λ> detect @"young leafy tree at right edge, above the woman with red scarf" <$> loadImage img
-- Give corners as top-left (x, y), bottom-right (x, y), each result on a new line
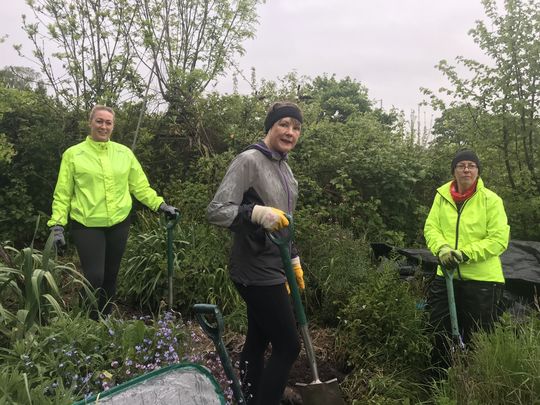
top-left (428, 0), bottom-right (540, 195)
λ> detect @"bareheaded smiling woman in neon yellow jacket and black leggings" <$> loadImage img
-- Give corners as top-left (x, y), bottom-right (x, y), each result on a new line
top-left (47, 105), bottom-right (176, 318)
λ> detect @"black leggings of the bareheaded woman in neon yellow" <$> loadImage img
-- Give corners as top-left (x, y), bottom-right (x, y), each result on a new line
top-left (71, 217), bottom-right (130, 319)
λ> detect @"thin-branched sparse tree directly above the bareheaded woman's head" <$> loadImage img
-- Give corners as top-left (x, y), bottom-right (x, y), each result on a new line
top-left (18, 0), bottom-right (141, 109)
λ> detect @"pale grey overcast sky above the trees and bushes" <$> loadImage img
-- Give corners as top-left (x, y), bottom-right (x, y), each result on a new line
top-left (0, 0), bottom-right (485, 116)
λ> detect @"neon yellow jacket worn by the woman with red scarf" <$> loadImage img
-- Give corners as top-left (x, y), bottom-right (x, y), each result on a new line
top-left (424, 178), bottom-right (510, 283)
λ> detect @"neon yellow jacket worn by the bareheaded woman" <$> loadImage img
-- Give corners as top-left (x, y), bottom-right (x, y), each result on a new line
top-left (47, 136), bottom-right (163, 227)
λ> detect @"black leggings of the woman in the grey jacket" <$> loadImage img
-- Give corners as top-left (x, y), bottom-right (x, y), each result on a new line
top-left (236, 284), bottom-right (300, 405)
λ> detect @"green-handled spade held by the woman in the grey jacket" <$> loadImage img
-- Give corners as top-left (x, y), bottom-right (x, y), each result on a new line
top-left (267, 215), bottom-right (345, 405)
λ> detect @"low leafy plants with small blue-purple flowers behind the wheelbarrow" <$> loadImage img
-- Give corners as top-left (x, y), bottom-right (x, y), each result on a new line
top-left (0, 312), bottom-right (234, 404)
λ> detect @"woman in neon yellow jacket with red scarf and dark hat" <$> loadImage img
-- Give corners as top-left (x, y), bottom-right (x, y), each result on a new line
top-left (424, 150), bottom-right (510, 366)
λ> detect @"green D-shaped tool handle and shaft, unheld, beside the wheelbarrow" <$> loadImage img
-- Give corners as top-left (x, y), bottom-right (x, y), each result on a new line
top-left (193, 304), bottom-right (246, 404)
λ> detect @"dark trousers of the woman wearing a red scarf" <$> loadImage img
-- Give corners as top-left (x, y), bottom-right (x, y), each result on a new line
top-left (428, 276), bottom-right (504, 368)
